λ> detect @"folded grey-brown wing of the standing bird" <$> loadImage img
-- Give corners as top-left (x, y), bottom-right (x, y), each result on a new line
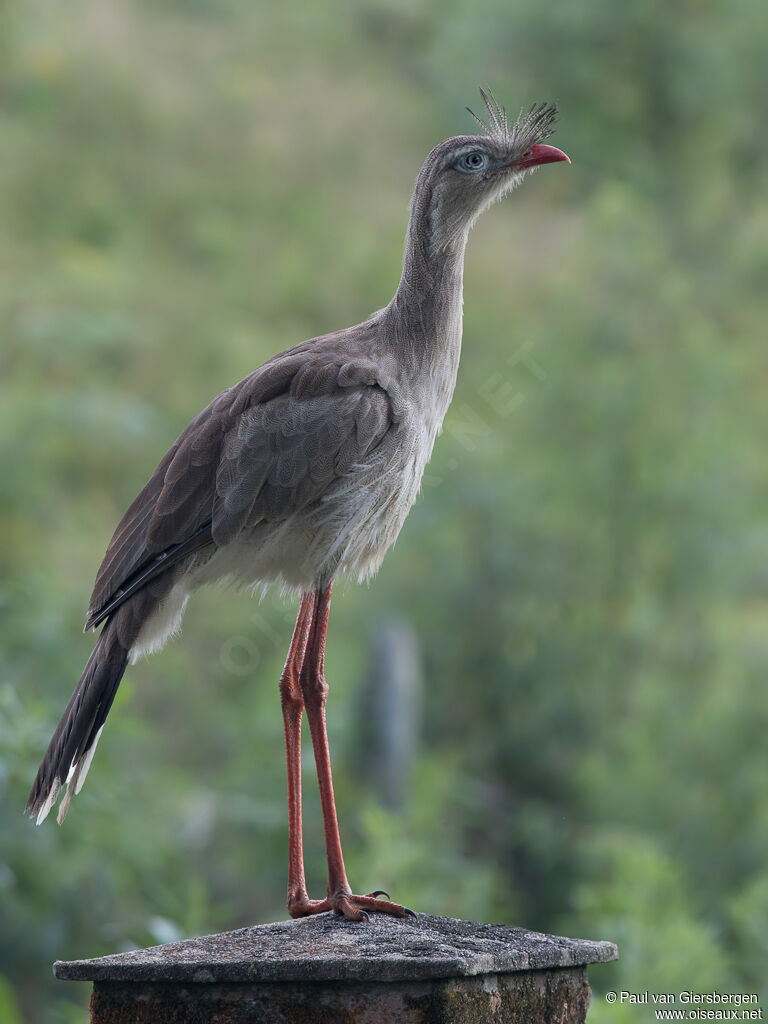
top-left (86, 343), bottom-right (397, 628)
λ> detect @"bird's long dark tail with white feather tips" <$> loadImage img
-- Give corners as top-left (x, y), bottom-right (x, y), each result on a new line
top-left (27, 609), bottom-right (129, 824)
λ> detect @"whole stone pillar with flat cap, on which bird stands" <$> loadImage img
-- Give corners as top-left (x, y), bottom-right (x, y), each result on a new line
top-left (53, 913), bottom-right (617, 1024)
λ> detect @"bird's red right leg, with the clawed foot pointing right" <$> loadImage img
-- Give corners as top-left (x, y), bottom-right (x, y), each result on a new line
top-left (294, 585), bottom-right (416, 921)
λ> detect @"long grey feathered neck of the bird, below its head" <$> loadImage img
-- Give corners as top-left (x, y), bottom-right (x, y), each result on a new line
top-left (385, 191), bottom-right (467, 372)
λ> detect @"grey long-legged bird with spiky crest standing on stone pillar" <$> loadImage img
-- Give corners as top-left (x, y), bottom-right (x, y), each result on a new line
top-left (26, 89), bottom-right (570, 921)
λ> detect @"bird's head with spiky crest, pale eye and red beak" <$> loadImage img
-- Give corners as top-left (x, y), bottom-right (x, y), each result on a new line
top-left (414, 89), bottom-right (570, 250)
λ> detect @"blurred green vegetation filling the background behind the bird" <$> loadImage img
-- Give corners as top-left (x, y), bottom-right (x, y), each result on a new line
top-left (0, 0), bottom-right (768, 1024)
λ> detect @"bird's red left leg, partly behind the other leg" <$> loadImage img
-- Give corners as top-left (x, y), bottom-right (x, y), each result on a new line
top-left (280, 594), bottom-right (328, 918)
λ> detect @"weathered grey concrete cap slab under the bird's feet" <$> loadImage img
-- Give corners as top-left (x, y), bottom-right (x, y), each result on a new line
top-left (53, 913), bottom-right (618, 984)
